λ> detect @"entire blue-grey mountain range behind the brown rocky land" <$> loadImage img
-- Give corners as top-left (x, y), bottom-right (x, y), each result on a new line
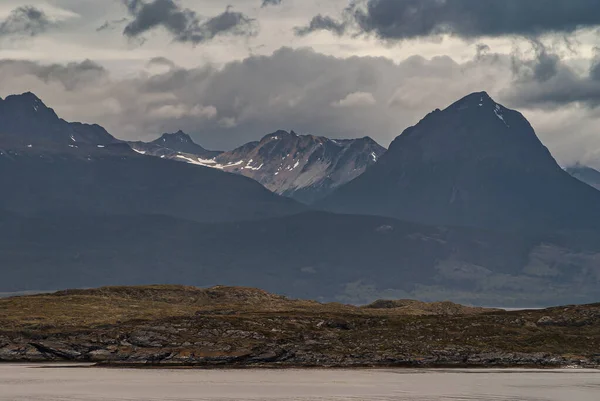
top-left (0, 93), bottom-right (600, 306)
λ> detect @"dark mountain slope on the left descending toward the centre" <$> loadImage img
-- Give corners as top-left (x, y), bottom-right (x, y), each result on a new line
top-left (0, 94), bottom-right (304, 221)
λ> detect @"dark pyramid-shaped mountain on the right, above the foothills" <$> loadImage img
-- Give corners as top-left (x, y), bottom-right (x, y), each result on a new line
top-left (319, 93), bottom-right (600, 231)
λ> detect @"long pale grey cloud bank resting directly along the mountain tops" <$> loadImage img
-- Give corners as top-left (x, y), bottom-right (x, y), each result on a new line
top-left (0, 47), bottom-right (600, 166)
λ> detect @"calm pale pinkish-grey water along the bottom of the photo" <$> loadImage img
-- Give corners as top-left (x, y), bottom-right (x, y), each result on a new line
top-left (0, 365), bottom-right (600, 401)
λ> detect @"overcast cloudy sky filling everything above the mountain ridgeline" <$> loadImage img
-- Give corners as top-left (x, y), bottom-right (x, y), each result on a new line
top-left (0, 0), bottom-right (600, 167)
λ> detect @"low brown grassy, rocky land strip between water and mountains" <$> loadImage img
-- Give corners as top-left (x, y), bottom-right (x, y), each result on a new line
top-left (0, 287), bottom-right (600, 369)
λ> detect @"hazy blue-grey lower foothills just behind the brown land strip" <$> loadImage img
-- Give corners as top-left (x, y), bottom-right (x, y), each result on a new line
top-left (0, 212), bottom-right (600, 306)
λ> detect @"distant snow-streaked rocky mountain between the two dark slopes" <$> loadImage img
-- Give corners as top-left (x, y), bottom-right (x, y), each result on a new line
top-left (130, 131), bottom-right (385, 203)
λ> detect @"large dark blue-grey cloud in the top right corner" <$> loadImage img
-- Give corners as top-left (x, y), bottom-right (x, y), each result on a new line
top-left (304, 0), bottom-right (600, 40)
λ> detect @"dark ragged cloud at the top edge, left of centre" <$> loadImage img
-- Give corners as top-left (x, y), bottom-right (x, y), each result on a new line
top-left (123, 0), bottom-right (257, 44)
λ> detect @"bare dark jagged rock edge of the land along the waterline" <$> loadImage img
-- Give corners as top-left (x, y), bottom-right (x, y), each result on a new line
top-left (0, 341), bottom-right (600, 369)
